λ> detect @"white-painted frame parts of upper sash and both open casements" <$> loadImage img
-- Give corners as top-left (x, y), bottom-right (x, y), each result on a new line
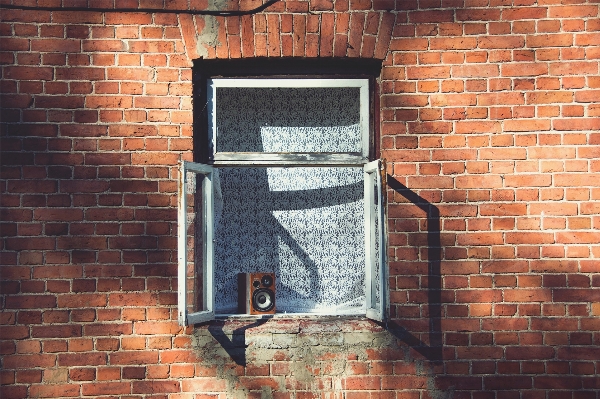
top-left (178, 78), bottom-right (388, 326)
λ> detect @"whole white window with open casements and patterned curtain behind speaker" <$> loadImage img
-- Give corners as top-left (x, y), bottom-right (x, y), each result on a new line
top-left (178, 68), bottom-right (387, 325)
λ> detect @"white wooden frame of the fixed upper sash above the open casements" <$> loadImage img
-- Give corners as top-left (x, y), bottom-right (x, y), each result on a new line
top-left (207, 78), bottom-right (370, 166)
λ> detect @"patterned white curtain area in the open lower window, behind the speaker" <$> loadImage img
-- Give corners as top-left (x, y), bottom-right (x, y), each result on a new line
top-left (214, 167), bottom-right (365, 314)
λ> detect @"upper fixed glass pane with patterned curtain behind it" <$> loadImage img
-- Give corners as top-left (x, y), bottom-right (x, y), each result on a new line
top-left (216, 87), bottom-right (362, 153)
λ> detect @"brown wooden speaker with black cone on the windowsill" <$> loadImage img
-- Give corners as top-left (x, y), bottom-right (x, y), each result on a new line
top-left (238, 273), bottom-right (275, 314)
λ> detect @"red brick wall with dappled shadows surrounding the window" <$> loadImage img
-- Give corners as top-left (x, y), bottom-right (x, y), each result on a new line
top-left (0, 0), bottom-right (600, 399)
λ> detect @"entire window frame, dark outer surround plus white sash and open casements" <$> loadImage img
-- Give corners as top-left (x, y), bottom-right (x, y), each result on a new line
top-left (178, 59), bottom-right (389, 325)
